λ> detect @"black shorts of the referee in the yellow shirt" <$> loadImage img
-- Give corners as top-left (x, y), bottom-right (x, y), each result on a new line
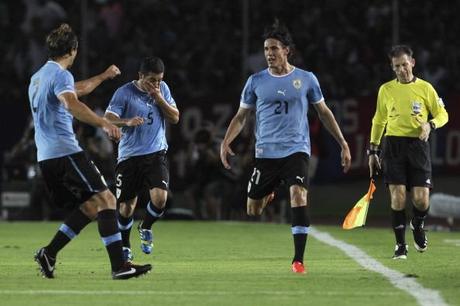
top-left (382, 136), bottom-right (433, 190)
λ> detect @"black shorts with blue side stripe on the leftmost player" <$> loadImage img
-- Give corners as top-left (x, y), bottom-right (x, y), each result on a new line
top-left (38, 152), bottom-right (107, 207)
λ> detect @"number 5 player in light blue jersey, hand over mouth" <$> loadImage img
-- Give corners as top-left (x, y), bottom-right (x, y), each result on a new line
top-left (105, 57), bottom-right (179, 260)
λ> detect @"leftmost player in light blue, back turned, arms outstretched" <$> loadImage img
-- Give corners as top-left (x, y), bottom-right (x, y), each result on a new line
top-left (29, 24), bottom-right (151, 279)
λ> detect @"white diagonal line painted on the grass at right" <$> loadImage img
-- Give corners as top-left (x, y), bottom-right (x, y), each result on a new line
top-left (309, 228), bottom-right (448, 306)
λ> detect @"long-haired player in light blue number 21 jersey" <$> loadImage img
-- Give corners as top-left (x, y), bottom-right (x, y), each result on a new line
top-left (220, 21), bottom-right (351, 273)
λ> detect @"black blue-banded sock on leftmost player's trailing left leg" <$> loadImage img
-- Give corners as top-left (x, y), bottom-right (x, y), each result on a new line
top-left (45, 208), bottom-right (91, 258)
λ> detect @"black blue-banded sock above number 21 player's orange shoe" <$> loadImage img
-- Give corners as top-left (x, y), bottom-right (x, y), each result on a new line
top-left (291, 206), bottom-right (310, 263)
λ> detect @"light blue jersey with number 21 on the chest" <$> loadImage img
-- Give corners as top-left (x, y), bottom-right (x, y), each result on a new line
top-left (240, 68), bottom-right (324, 158)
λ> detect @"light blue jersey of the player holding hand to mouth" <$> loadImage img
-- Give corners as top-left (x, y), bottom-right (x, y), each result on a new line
top-left (106, 81), bottom-right (176, 162)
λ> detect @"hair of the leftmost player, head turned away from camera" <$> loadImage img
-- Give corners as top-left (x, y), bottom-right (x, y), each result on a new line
top-left (46, 23), bottom-right (78, 59)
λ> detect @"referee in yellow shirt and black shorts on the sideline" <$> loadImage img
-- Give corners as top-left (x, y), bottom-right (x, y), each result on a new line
top-left (368, 45), bottom-right (448, 259)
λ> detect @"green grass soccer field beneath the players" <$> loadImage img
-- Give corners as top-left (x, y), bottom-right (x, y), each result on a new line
top-left (0, 221), bottom-right (460, 306)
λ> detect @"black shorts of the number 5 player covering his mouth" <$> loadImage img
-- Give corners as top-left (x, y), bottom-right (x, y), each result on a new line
top-left (115, 150), bottom-right (169, 202)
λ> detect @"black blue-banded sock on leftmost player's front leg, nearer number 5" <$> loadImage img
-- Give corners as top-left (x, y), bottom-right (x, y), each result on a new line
top-left (97, 209), bottom-right (124, 271)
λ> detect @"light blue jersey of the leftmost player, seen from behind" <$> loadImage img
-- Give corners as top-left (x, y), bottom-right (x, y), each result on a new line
top-left (29, 61), bottom-right (82, 161)
